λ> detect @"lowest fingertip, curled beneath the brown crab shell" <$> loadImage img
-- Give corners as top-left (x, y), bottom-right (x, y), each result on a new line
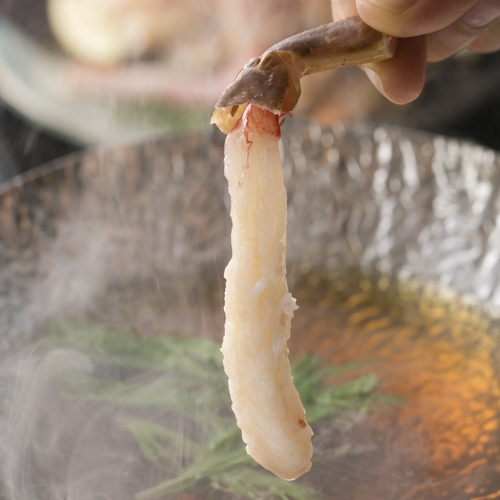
top-left (363, 36), bottom-right (427, 104)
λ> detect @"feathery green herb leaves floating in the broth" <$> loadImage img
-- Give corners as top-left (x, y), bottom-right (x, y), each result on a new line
top-left (50, 325), bottom-right (387, 500)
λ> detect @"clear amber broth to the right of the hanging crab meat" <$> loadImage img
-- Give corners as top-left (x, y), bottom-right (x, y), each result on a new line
top-left (290, 271), bottom-right (500, 499)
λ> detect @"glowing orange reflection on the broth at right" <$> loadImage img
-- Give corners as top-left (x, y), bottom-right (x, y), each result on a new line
top-left (290, 274), bottom-right (500, 482)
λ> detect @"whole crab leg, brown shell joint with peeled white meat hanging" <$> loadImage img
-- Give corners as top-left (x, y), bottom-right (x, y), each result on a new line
top-left (212, 17), bottom-right (394, 480)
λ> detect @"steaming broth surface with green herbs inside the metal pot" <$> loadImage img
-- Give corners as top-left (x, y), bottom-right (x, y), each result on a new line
top-left (2, 270), bottom-right (500, 500)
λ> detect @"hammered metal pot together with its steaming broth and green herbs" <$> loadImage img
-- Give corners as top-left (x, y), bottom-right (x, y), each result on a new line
top-left (1, 124), bottom-right (500, 499)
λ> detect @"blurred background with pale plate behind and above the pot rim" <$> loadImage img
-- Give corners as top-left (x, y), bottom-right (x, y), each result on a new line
top-left (0, 0), bottom-right (500, 182)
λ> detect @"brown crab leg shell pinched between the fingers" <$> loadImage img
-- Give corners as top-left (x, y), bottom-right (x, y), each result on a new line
top-left (210, 17), bottom-right (395, 134)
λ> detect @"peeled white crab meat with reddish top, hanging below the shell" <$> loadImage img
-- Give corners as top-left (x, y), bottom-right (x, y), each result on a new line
top-left (222, 105), bottom-right (313, 480)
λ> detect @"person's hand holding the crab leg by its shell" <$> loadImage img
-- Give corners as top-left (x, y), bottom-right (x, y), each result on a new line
top-left (331, 0), bottom-right (500, 104)
